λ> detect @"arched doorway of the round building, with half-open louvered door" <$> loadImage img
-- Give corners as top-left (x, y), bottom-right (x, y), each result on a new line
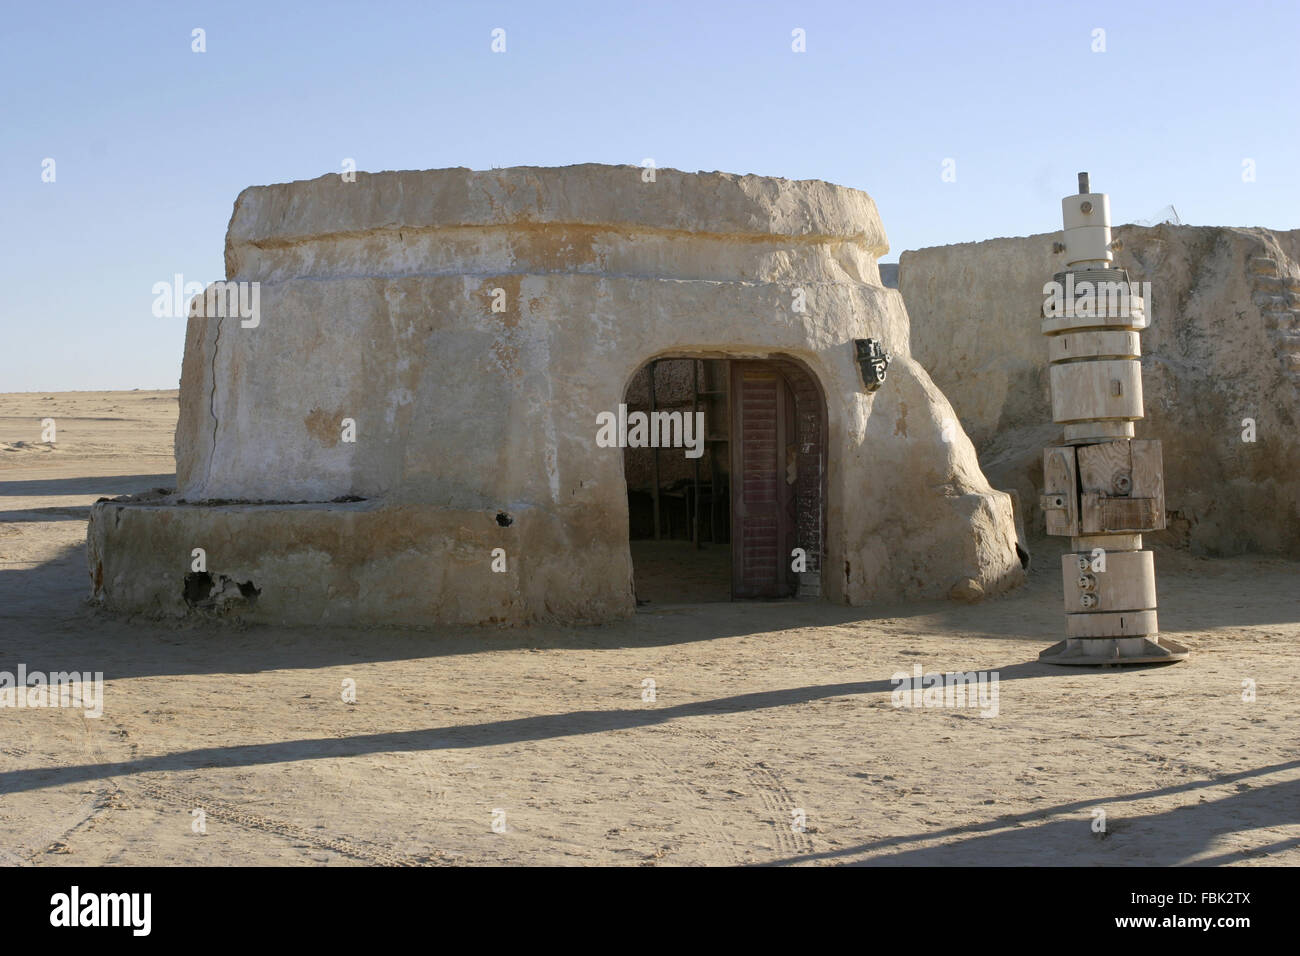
top-left (624, 354), bottom-right (827, 606)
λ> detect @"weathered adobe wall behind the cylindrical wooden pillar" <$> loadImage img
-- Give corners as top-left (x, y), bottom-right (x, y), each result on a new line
top-left (898, 224), bottom-right (1300, 555)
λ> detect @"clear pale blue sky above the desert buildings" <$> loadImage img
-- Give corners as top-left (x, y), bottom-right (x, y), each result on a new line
top-left (0, 0), bottom-right (1300, 392)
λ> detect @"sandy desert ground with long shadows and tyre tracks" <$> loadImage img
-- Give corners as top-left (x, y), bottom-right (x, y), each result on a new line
top-left (0, 392), bottom-right (1300, 865)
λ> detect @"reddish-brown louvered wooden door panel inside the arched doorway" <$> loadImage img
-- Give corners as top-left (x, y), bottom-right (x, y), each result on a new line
top-left (731, 362), bottom-right (794, 598)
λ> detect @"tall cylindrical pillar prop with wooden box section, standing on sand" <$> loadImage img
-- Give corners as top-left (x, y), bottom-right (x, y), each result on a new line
top-left (1039, 173), bottom-right (1187, 666)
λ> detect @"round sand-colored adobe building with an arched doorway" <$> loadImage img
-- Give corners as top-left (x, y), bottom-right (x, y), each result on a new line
top-left (88, 165), bottom-right (1023, 624)
